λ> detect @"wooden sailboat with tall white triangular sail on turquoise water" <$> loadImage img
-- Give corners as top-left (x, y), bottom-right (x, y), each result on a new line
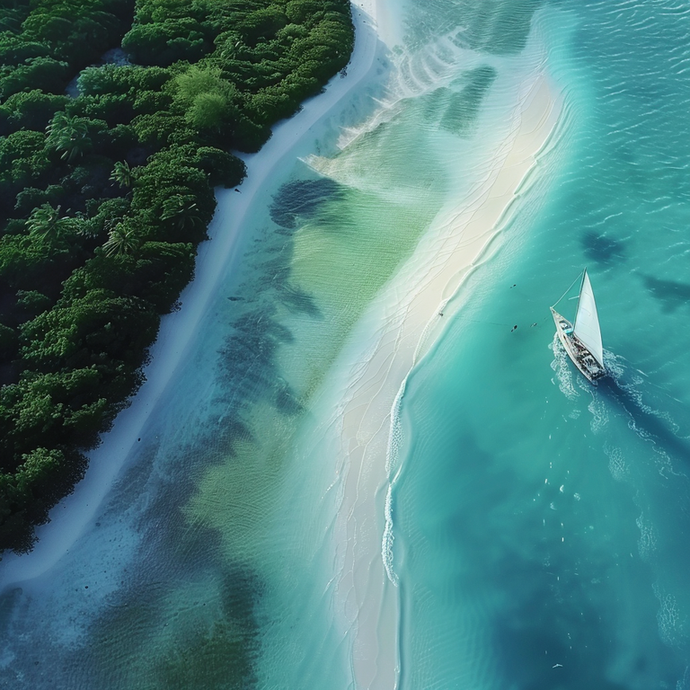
top-left (551, 269), bottom-right (607, 382)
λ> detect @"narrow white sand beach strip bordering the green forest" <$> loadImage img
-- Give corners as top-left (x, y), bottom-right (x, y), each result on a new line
top-left (0, 0), bottom-right (378, 591)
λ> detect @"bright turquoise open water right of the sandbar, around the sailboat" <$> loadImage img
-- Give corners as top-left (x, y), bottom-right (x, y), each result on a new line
top-left (394, 3), bottom-right (690, 690)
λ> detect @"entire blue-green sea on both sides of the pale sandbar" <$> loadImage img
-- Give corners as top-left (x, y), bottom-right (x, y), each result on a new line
top-left (0, 0), bottom-right (690, 690)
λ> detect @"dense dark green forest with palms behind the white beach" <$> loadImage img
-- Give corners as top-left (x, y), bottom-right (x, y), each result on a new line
top-left (0, 0), bottom-right (354, 551)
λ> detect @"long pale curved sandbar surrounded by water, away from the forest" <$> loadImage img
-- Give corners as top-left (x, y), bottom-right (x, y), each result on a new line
top-left (330, 68), bottom-right (561, 690)
